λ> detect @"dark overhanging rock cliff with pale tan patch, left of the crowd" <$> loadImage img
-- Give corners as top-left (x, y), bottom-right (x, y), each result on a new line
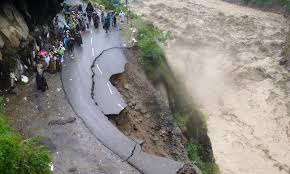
top-left (0, 0), bottom-right (63, 89)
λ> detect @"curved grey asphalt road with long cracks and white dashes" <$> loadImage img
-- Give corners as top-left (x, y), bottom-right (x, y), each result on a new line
top-left (60, 1), bottom-right (183, 174)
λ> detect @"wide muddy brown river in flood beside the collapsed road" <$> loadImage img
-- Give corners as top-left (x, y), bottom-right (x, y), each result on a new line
top-left (131, 0), bottom-right (290, 174)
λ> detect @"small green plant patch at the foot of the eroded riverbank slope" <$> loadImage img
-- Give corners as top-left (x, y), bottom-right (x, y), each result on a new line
top-left (186, 140), bottom-right (220, 174)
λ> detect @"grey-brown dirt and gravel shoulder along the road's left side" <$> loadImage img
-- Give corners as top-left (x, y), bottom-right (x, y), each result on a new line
top-left (5, 74), bottom-right (139, 174)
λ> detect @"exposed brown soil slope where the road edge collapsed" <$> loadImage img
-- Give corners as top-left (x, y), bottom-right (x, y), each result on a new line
top-left (111, 50), bottom-right (188, 161)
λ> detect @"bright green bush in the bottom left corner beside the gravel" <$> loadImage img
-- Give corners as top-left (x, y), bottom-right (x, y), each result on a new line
top-left (0, 97), bottom-right (51, 174)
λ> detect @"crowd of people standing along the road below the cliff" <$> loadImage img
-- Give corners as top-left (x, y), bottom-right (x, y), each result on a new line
top-left (17, 3), bottom-right (125, 92)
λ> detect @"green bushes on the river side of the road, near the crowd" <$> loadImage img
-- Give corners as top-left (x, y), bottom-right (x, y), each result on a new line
top-left (123, 14), bottom-right (173, 81)
